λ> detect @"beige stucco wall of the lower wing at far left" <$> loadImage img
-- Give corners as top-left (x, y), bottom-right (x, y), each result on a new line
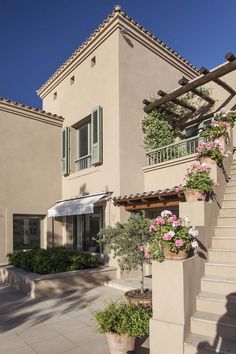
top-left (0, 106), bottom-right (61, 262)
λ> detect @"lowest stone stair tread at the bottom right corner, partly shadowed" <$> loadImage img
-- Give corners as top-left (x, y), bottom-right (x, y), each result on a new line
top-left (186, 333), bottom-right (236, 354)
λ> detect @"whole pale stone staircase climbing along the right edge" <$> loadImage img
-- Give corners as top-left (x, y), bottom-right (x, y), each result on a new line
top-left (184, 160), bottom-right (236, 354)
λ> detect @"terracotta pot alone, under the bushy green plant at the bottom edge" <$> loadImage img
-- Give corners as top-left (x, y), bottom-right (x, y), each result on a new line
top-left (106, 333), bottom-right (135, 354)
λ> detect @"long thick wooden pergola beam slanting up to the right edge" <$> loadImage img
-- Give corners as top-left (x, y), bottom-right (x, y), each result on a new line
top-left (144, 53), bottom-right (236, 113)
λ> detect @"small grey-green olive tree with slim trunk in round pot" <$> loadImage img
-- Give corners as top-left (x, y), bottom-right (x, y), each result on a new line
top-left (97, 213), bottom-right (152, 306)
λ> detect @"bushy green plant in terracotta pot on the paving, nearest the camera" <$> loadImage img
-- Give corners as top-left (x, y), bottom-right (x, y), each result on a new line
top-left (94, 301), bottom-right (152, 354)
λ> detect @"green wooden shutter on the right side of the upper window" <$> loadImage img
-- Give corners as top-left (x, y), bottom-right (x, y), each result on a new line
top-left (91, 106), bottom-right (103, 165)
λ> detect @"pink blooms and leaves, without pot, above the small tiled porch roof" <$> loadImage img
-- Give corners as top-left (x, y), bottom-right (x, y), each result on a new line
top-left (182, 161), bottom-right (215, 199)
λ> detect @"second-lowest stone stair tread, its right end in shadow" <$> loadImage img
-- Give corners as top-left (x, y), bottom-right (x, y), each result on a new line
top-left (192, 311), bottom-right (236, 328)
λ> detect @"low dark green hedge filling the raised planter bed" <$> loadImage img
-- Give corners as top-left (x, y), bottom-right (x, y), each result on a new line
top-left (9, 247), bottom-right (99, 274)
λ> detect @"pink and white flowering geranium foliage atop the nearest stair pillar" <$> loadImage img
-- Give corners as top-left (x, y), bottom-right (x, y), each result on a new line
top-left (140, 210), bottom-right (198, 262)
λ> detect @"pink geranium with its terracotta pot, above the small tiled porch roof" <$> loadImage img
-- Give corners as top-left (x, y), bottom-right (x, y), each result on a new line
top-left (181, 161), bottom-right (217, 201)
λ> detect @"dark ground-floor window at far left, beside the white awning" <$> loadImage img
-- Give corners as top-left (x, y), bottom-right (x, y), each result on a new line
top-left (13, 215), bottom-right (42, 250)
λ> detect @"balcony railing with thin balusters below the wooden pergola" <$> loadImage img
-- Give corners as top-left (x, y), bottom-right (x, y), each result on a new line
top-left (147, 136), bottom-right (203, 166)
